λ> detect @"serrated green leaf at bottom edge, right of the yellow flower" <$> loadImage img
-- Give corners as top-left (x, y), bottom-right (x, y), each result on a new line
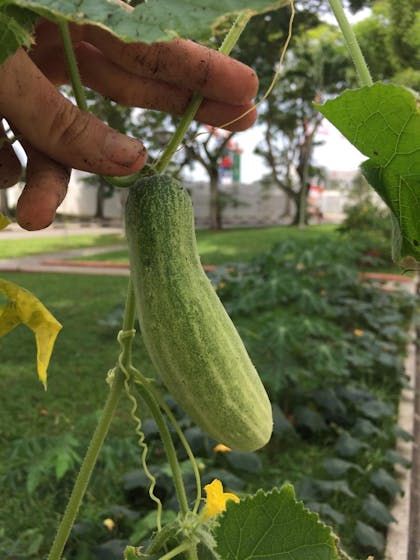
top-left (215, 484), bottom-right (340, 560)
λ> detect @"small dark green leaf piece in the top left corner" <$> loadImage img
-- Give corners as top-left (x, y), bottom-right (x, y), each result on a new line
top-left (0, 3), bottom-right (38, 63)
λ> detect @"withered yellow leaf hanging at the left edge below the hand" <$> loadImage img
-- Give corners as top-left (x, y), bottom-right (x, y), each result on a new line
top-left (0, 279), bottom-right (62, 388)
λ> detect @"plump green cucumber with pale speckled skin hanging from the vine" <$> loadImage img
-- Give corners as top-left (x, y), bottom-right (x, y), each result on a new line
top-left (126, 175), bottom-right (273, 451)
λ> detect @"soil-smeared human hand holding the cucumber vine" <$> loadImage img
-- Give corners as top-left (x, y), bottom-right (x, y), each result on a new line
top-left (0, 20), bottom-right (258, 230)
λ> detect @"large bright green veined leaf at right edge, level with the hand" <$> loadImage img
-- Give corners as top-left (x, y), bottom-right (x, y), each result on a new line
top-left (318, 83), bottom-right (420, 260)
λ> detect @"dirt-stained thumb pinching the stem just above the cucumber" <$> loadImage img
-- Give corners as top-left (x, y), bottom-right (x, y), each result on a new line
top-left (0, 49), bottom-right (147, 175)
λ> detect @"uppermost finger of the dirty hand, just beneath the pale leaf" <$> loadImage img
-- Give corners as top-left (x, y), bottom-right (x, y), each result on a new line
top-left (84, 25), bottom-right (258, 105)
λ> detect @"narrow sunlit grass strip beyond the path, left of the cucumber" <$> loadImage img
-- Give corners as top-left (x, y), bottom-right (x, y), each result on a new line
top-left (0, 232), bottom-right (124, 259)
